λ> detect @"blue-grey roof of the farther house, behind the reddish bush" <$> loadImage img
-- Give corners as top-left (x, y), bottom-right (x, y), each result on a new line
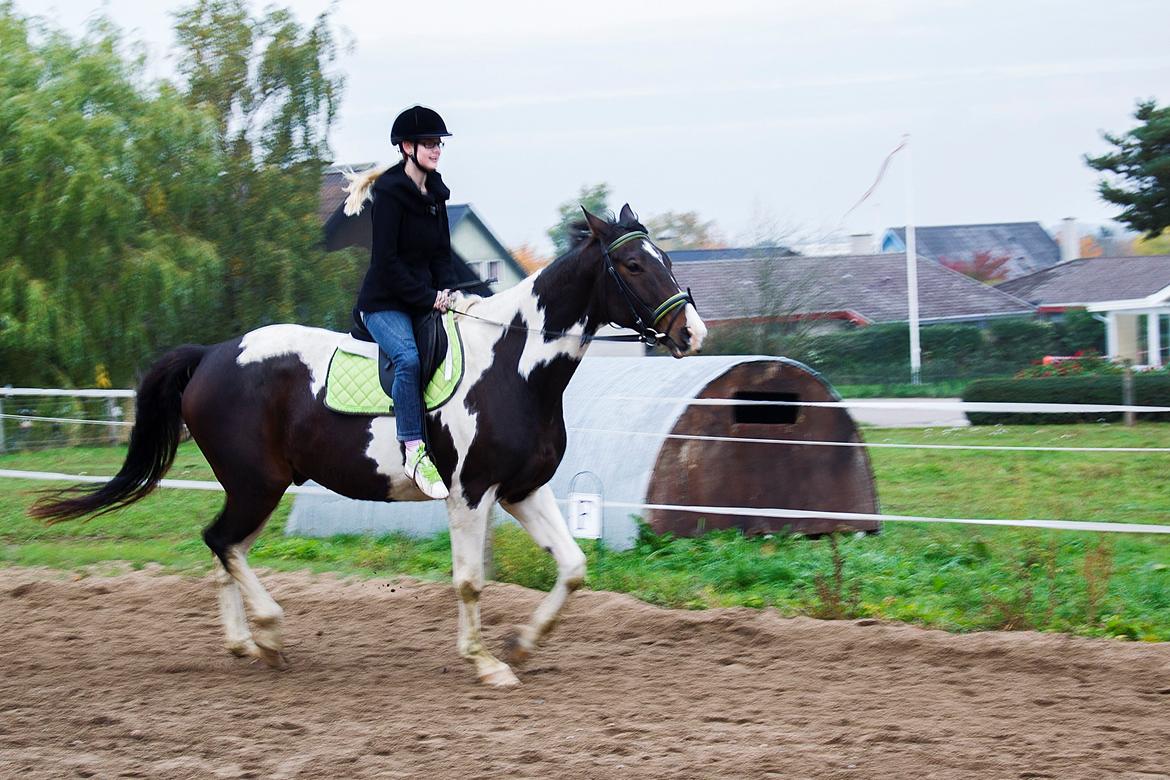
top-left (882, 222), bottom-right (1060, 278)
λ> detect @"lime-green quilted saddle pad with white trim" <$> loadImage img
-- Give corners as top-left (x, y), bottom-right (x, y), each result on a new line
top-left (325, 311), bottom-right (463, 414)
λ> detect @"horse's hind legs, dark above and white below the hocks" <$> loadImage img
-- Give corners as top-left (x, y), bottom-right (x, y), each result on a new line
top-left (204, 488), bottom-right (284, 668)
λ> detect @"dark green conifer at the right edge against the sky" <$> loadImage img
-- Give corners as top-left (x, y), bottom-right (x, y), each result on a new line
top-left (1085, 101), bottom-right (1170, 237)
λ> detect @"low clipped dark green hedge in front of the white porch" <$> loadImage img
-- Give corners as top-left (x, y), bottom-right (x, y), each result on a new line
top-left (963, 372), bottom-right (1170, 426)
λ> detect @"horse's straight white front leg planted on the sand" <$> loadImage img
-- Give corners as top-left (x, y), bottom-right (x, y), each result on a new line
top-left (447, 498), bottom-right (519, 688)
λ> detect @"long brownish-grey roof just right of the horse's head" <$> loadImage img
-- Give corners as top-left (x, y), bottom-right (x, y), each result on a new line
top-left (670, 253), bottom-right (1034, 323)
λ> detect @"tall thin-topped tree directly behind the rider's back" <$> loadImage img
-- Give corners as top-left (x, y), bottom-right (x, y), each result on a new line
top-left (176, 0), bottom-right (346, 336)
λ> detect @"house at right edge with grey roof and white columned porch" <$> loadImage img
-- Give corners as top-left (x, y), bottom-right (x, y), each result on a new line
top-left (996, 255), bottom-right (1170, 366)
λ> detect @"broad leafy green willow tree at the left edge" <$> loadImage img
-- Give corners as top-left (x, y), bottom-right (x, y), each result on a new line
top-left (0, 4), bottom-right (221, 385)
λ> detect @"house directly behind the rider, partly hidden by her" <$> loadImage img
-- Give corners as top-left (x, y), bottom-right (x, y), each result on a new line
top-left (317, 164), bottom-right (527, 295)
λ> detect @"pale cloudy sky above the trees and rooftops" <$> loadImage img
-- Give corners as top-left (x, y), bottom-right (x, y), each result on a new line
top-left (15, 0), bottom-right (1170, 251)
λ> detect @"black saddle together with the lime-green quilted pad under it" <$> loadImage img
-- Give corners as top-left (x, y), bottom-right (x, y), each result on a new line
top-left (325, 311), bottom-right (463, 415)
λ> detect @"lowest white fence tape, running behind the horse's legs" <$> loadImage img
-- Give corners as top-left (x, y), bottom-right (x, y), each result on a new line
top-left (0, 469), bottom-right (1170, 534)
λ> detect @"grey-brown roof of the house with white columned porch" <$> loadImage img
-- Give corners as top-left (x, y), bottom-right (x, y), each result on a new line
top-left (996, 255), bottom-right (1170, 306)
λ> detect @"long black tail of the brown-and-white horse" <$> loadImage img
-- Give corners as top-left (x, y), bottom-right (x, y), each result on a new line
top-left (28, 345), bottom-right (207, 523)
